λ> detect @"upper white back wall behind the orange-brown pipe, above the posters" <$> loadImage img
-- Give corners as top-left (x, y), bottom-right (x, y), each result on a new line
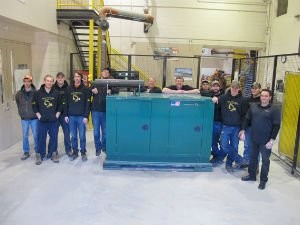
top-left (105, 0), bottom-right (267, 53)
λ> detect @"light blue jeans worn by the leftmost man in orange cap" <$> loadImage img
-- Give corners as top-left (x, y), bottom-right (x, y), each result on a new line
top-left (21, 119), bottom-right (38, 152)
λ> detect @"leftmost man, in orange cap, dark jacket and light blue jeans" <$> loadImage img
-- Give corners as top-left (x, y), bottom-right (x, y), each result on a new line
top-left (16, 74), bottom-right (38, 160)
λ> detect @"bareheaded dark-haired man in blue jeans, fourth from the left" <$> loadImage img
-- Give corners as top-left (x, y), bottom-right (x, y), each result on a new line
top-left (64, 72), bottom-right (91, 162)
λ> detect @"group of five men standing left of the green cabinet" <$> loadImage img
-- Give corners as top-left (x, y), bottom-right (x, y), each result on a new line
top-left (16, 68), bottom-right (115, 165)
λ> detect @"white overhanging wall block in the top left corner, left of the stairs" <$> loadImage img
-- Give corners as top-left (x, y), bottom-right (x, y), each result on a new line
top-left (0, 0), bottom-right (57, 33)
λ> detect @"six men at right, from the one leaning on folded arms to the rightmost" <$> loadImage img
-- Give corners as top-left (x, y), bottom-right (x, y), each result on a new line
top-left (162, 77), bottom-right (281, 189)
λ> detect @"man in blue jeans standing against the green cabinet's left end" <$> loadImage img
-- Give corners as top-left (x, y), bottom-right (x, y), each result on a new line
top-left (91, 68), bottom-right (118, 156)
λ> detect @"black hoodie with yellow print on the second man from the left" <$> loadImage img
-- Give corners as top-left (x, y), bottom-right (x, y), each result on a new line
top-left (32, 84), bottom-right (62, 122)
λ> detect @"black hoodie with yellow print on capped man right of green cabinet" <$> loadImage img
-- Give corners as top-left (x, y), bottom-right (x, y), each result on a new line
top-left (218, 90), bottom-right (249, 126)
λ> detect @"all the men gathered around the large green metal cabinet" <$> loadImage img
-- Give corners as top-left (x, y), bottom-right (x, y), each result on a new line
top-left (16, 72), bottom-right (280, 189)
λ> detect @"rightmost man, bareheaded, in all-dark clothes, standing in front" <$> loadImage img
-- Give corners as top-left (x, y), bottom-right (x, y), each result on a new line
top-left (240, 89), bottom-right (280, 190)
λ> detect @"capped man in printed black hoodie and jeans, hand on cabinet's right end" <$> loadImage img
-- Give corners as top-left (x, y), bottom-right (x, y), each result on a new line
top-left (213, 80), bottom-right (248, 172)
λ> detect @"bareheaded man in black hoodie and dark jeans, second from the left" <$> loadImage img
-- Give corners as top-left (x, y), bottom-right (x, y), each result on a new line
top-left (32, 75), bottom-right (62, 165)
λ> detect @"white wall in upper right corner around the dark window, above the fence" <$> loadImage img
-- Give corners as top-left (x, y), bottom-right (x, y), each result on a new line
top-left (266, 0), bottom-right (300, 55)
